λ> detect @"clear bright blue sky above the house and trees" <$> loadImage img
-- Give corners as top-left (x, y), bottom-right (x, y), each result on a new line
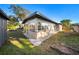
top-left (0, 4), bottom-right (79, 23)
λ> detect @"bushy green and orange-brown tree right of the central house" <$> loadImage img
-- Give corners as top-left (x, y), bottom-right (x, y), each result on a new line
top-left (60, 19), bottom-right (71, 31)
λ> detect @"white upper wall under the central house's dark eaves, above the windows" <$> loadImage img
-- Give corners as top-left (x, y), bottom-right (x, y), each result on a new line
top-left (25, 18), bottom-right (57, 33)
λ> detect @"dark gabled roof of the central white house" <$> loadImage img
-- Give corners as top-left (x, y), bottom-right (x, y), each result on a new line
top-left (22, 11), bottom-right (58, 24)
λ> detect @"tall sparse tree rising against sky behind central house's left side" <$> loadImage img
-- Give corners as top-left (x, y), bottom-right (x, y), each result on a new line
top-left (10, 5), bottom-right (30, 20)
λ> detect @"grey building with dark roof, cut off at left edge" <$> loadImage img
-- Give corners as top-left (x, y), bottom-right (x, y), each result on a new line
top-left (0, 9), bottom-right (9, 47)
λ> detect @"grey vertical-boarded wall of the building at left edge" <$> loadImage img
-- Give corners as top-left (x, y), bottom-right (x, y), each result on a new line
top-left (0, 18), bottom-right (7, 46)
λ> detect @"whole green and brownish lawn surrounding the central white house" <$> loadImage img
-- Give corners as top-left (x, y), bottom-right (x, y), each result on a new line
top-left (0, 30), bottom-right (79, 55)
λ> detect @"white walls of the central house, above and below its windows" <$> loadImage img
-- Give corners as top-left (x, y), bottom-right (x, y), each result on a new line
top-left (24, 18), bottom-right (59, 39)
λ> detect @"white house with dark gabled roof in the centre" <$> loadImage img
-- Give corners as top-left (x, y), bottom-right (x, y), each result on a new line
top-left (22, 11), bottom-right (62, 46)
